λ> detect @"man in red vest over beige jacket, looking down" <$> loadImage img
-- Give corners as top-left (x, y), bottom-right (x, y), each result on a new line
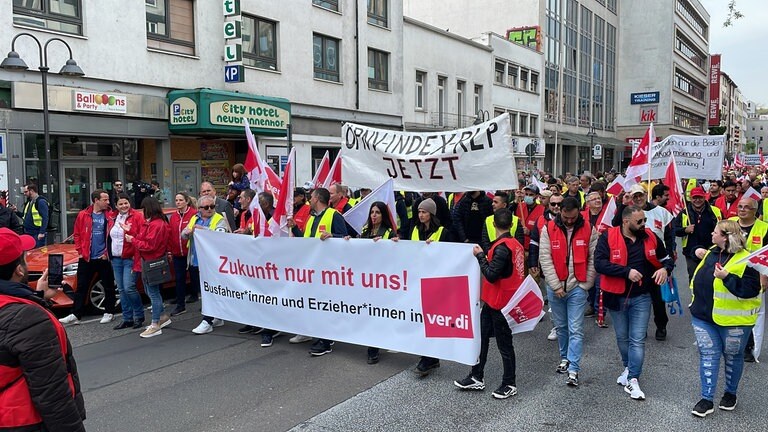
top-left (539, 197), bottom-right (597, 387)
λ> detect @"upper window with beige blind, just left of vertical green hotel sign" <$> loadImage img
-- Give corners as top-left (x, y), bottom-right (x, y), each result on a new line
top-left (145, 0), bottom-right (195, 55)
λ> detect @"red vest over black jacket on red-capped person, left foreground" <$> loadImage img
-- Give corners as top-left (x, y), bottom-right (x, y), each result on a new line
top-left (0, 295), bottom-right (75, 430)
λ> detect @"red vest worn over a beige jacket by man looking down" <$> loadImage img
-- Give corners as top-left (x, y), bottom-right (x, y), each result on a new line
top-left (547, 220), bottom-right (592, 282)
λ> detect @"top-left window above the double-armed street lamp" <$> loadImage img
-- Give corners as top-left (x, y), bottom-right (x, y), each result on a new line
top-left (13, 0), bottom-right (83, 35)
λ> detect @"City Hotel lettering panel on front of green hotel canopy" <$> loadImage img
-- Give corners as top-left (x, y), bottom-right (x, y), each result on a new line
top-left (210, 100), bottom-right (291, 129)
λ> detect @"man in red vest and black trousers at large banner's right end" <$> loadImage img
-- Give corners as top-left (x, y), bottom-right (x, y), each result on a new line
top-left (453, 208), bottom-right (525, 399)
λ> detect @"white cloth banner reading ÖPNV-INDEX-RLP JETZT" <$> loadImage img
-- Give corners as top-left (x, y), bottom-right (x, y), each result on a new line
top-left (341, 114), bottom-right (518, 192)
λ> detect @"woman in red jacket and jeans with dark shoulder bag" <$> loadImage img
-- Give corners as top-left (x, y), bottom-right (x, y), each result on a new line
top-left (125, 197), bottom-right (171, 338)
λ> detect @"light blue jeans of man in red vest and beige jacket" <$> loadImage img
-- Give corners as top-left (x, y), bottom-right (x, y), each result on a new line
top-left (547, 286), bottom-right (587, 372)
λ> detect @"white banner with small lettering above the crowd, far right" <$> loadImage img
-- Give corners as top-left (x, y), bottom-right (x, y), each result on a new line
top-left (642, 135), bottom-right (725, 180)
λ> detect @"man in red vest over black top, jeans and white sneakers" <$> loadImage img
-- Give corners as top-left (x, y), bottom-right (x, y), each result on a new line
top-left (595, 205), bottom-right (675, 400)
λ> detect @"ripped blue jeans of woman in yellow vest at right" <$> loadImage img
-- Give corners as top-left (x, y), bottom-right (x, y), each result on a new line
top-left (691, 317), bottom-right (752, 401)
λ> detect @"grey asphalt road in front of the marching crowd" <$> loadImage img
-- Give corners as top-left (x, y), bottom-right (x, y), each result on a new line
top-left (68, 253), bottom-right (768, 432)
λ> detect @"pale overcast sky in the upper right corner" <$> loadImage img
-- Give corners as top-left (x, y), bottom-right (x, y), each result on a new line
top-left (700, 0), bottom-right (768, 107)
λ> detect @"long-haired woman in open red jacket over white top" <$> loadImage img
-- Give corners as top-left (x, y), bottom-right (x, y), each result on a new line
top-left (107, 192), bottom-right (144, 330)
